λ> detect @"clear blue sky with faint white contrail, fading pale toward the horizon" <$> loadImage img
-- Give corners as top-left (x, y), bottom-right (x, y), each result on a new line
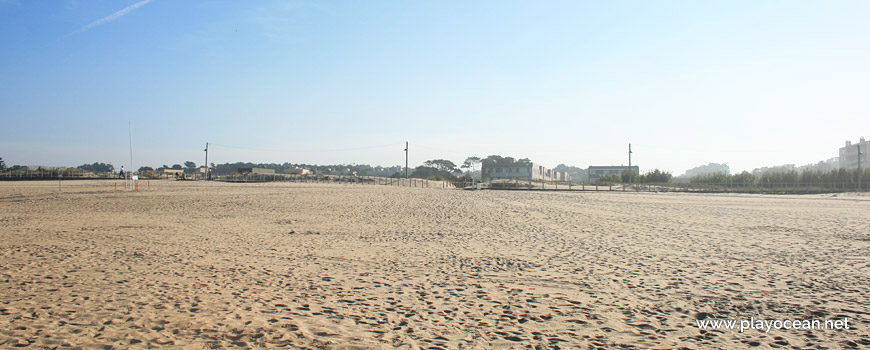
top-left (0, 0), bottom-right (870, 174)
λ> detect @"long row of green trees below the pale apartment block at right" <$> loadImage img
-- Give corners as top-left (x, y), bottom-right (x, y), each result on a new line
top-left (690, 168), bottom-right (870, 185)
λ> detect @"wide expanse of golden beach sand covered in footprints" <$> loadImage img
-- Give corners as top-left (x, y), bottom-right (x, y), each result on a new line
top-left (0, 180), bottom-right (870, 349)
